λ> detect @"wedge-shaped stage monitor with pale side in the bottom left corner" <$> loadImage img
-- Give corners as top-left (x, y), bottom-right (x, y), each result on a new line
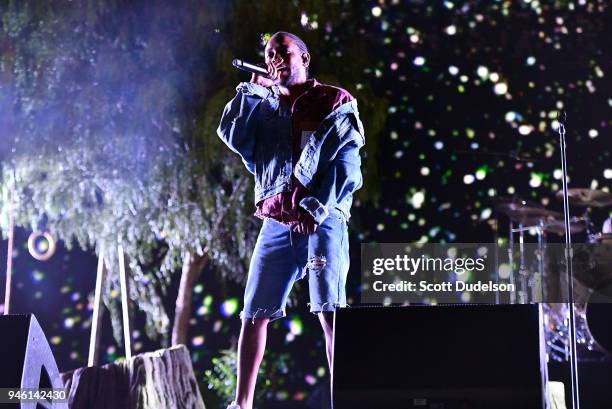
top-left (0, 314), bottom-right (68, 409)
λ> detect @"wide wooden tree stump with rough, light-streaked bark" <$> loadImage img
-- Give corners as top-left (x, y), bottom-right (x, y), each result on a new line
top-left (62, 345), bottom-right (205, 409)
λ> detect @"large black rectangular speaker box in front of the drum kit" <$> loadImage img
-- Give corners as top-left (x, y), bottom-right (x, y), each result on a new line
top-left (332, 305), bottom-right (547, 409)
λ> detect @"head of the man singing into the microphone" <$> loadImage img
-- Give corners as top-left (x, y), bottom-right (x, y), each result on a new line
top-left (265, 35), bottom-right (310, 86)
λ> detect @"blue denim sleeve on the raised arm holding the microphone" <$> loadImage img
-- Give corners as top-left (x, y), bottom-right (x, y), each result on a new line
top-left (217, 82), bottom-right (271, 173)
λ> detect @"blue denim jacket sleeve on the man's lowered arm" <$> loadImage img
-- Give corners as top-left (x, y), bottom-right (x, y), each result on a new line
top-left (295, 114), bottom-right (364, 224)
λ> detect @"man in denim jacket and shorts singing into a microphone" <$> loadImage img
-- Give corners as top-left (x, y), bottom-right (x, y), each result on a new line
top-left (217, 32), bottom-right (365, 409)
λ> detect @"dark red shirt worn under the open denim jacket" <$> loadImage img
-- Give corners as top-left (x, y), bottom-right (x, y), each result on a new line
top-left (255, 79), bottom-right (353, 224)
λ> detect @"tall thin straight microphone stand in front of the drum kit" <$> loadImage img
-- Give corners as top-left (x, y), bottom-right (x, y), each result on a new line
top-left (557, 112), bottom-right (580, 409)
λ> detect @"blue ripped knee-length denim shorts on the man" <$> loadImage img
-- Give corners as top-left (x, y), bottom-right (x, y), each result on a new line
top-left (240, 210), bottom-right (349, 321)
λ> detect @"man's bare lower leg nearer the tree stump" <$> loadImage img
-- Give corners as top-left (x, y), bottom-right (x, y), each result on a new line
top-left (236, 318), bottom-right (270, 409)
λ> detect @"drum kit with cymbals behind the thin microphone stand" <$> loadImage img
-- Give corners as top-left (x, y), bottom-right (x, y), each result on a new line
top-left (495, 188), bottom-right (612, 361)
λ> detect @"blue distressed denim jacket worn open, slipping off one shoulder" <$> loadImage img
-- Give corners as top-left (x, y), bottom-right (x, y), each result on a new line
top-left (217, 82), bottom-right (365, 224)
